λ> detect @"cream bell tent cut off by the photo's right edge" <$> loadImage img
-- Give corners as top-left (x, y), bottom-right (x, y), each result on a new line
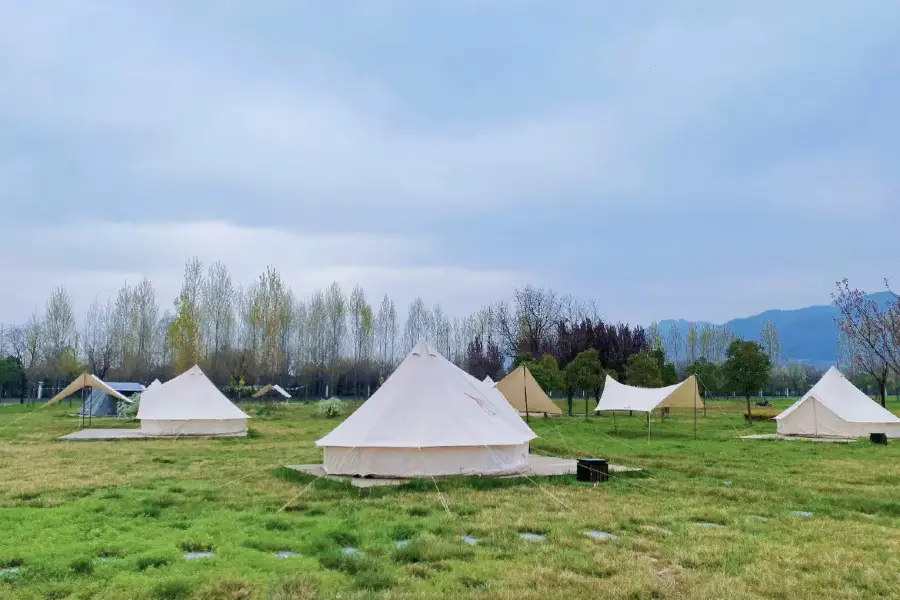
top-left (775, 367), bottom-right (900, 438)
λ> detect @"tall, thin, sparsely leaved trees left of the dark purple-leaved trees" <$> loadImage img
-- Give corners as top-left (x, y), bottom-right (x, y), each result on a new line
top-left (0, 258), bottom-right (646, 395)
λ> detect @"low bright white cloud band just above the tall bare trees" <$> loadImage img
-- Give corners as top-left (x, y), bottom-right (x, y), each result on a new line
top-left (0, 221), bottom-right (529, 323)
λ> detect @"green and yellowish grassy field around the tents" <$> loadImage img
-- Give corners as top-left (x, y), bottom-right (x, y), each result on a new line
top-left (0, 402), bottom-right (900, 600)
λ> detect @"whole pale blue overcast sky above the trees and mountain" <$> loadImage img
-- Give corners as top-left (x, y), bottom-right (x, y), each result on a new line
top-left (0, 0), bottom-right (900, 323)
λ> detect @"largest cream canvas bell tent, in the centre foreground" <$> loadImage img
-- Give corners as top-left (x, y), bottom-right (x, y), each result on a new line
top-left (316, 342), bottom-right (535, 477)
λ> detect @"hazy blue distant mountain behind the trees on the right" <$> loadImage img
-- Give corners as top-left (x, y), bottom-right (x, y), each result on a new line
top-left (659, 291), bottom-right (897, 367)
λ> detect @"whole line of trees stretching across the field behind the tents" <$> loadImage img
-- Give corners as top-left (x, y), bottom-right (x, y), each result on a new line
top-left (0, 258), bottom-right (900, 411)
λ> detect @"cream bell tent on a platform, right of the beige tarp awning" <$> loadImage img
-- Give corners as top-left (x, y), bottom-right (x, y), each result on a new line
top-left (137, 366), bottom-right (250, 436)
